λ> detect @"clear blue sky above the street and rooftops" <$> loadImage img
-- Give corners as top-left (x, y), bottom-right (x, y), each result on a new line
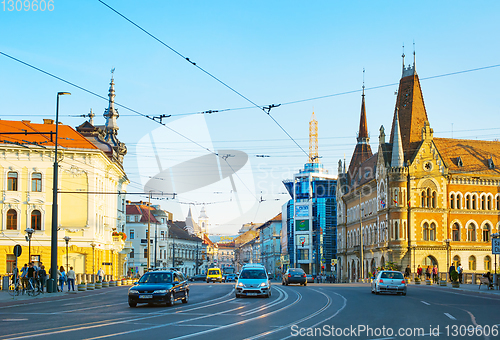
top-left (0, 0), bottom-right (500, 234)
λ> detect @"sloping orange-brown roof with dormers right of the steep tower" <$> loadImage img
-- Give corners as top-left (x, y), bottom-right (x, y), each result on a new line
top-left (433, 138), bottom-right (500, 176)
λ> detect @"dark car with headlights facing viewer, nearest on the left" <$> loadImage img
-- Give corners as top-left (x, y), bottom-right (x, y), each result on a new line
top-left (128, 270), bottom-right (189, 307)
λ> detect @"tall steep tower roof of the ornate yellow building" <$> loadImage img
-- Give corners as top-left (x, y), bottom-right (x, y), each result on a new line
top-left (389, 72), bottom-right (428, 161)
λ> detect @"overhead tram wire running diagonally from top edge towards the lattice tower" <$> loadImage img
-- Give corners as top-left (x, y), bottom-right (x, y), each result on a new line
top-left (98, 0), bottom-right (309, 161)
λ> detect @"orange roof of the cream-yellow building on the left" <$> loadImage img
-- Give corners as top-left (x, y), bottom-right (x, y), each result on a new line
top-left (0, 119), bottom-right (98, 150)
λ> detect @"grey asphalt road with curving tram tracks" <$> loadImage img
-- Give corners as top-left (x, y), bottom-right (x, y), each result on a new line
top-left (0, 283), bottom-right (500, 340)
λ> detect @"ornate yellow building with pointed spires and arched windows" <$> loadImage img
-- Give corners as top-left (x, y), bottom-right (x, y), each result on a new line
top-left (337, 59), bottom-right (500, 281)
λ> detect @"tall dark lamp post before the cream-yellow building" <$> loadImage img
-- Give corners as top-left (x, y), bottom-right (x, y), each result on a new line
top-left (47, 92), bottom-right (71, 293)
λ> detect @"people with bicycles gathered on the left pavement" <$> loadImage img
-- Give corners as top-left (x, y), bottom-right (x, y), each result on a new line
top-left (12, 262), bottom-right (76, 293)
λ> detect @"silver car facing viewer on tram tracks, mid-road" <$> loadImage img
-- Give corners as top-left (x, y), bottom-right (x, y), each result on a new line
top-left (234, 267), bottom-right (271, 298)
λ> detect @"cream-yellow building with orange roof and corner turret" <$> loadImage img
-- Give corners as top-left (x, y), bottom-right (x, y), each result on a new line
top-left (0, 80), bottom-right (129, 281)
